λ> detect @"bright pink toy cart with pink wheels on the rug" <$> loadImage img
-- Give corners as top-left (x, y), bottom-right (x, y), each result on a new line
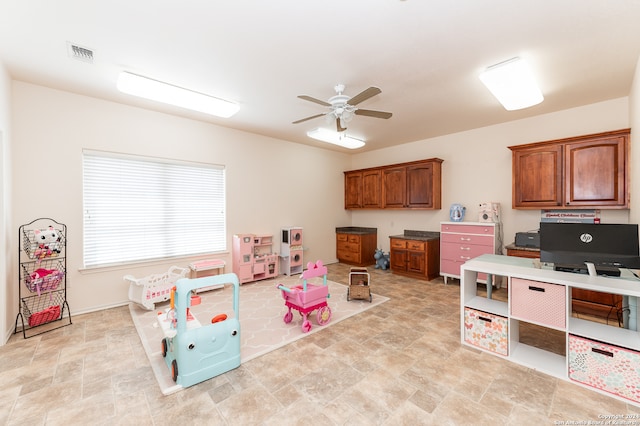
top-left (278, 260), bottom-right (331, 333)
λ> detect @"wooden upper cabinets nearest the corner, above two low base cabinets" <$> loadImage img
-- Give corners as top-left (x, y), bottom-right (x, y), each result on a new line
top-left (344, 158), bottom-right (442, 209)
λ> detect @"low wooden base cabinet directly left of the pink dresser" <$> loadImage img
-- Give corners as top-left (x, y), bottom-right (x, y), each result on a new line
top-left (389, 237), bottom-right (440, 280)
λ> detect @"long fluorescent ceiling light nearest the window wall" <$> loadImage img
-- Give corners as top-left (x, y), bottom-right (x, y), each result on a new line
top-left (118, 71), bottom-right (240, 118)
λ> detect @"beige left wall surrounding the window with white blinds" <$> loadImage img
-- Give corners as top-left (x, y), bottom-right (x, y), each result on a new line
top-left (7, 81), bottom-right (350, 318)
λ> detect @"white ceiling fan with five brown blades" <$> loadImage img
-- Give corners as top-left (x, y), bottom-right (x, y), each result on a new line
top-left (293, 84), bottom-right (392, 133)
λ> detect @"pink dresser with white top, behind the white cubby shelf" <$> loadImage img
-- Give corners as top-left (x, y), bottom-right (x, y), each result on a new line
top-left (440, 222), bottom-right (502, 283)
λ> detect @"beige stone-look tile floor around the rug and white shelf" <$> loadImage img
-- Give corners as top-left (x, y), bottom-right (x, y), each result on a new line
top-left (0, 264), bottom-right (640, 426)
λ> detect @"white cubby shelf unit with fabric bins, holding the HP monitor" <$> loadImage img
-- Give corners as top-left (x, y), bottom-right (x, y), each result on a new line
top-left (460, 254), bottom-right (640, 406)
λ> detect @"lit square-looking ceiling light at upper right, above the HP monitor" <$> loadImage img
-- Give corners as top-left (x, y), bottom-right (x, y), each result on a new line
top-left (479, 58), bottom-right (544, 111)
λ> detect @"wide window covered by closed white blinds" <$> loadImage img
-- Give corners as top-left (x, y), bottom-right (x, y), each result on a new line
top-left (83, 151), bottom-right (226, 267)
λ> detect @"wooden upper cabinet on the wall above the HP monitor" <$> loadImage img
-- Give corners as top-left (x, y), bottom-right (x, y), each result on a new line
top-left (509, 129), bottom-right (630, 209)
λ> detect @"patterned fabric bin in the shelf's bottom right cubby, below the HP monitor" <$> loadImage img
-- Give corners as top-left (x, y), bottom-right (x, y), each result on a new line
top-left (569, 335), bottom-right (640, 402)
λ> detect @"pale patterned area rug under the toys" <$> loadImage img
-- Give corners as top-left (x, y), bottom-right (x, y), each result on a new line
top-left (129, 276), bottom-right (389, 395)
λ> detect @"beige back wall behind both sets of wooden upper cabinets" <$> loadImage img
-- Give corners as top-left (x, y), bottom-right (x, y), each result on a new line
top-left (344, 98), bottom-right (638, 251)
